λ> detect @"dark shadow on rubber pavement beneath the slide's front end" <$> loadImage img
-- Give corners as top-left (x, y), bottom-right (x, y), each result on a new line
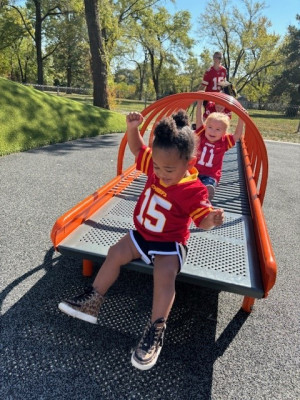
top-left (0, 248), bottom-right (248, 400)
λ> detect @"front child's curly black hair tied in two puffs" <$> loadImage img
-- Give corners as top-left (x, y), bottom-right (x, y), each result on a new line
top-left (153, 110), bottom-right (196, 160)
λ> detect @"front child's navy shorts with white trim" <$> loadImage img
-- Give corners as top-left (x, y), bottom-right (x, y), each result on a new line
top-left (129, 230), bottom-right (188, 272)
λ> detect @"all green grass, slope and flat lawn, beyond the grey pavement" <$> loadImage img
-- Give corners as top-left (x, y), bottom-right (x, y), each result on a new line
top-left (0, 78), bottom-right (300, 155)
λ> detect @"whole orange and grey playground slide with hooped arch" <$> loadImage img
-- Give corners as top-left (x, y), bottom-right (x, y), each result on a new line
top-left (51, 92), bottom-right (277, 312)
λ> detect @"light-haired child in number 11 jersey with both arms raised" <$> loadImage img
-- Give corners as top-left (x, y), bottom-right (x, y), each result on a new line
top-left (195, 101), bottom-right (244, 200)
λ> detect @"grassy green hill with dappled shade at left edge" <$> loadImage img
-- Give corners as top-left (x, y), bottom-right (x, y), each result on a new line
top-left (0, 78), bottom-right (126, 155)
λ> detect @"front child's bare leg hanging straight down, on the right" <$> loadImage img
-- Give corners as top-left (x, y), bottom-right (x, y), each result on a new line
top-left (151, 255), bottom-right (179, 322)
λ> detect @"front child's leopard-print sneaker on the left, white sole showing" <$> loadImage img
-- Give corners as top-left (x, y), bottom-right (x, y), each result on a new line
top-left (58, 287), bottom-right (105, 324)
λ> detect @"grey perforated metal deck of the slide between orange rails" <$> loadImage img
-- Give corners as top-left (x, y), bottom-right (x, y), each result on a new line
top-left (59, 144), bottom-right (264, 297)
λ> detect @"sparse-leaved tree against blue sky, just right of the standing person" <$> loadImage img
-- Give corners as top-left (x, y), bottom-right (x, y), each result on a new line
top-left (200, 0), bottom-right (280, 91)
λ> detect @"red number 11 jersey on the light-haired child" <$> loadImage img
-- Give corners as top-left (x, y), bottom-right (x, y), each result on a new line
top-left (195, 125), bottom-right (235, 182)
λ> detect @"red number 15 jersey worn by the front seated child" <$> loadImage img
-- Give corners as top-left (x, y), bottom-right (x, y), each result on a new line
top-left (133, 146), bottom-right (212, 244)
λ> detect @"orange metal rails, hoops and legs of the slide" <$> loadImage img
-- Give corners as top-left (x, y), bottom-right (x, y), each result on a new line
top-left (51, 92), bottom-right (277, 312)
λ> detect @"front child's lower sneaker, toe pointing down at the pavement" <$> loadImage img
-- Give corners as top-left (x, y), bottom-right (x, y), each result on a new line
top-left (131, 318), bottom-right (166, 370)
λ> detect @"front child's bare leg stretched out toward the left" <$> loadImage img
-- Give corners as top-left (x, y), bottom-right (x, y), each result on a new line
top-left (93, 233), bottom-right (140, 296)
